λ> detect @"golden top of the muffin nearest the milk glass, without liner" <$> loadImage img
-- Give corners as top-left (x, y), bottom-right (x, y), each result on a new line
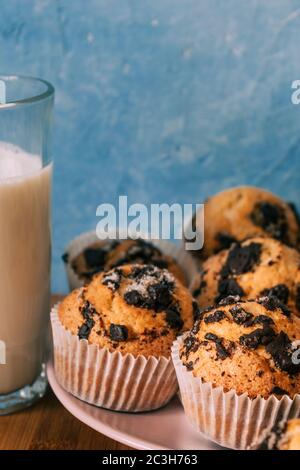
top-left (58, 265), bottom-right (195, 357)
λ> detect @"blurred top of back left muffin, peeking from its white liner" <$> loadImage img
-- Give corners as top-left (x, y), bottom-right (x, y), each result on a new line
top-left (63, 238), bottom-right (185, 284)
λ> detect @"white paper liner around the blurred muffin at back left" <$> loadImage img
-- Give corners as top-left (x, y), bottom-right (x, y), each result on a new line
top-left (65, 230), bottom-right (197, 291)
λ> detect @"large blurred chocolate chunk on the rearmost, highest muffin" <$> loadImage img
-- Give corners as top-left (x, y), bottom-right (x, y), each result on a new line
top-left (250, 201), bottom-right (288, 242)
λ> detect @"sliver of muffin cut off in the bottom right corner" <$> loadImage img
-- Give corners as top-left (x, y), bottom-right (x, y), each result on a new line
top-left (252, 419), bottom-right (300, 450)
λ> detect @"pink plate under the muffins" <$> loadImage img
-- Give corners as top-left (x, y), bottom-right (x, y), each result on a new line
top-left (47, 362), bottom-right (221, 450)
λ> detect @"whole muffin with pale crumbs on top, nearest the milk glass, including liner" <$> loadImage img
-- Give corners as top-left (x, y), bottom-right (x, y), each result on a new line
top-left (51, 265), bottom-right (195, 411)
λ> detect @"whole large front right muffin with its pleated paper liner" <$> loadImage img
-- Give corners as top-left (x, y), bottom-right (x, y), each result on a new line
top-left (172, 297), bottom-right (300, 449)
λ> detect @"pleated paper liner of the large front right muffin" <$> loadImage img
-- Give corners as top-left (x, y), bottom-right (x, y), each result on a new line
top-left (172, 335), bottom-right (300, 449)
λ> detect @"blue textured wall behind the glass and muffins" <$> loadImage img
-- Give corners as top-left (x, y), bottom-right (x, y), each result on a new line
top-left (0, 0), bottom-right (300, 290)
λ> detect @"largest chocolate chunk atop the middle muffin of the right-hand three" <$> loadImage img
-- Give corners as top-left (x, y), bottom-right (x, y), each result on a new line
top-left (221, 243), bottom-right (261, 278)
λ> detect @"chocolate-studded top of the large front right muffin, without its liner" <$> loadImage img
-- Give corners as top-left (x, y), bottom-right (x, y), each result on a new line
top-left (180, 297), bottom-right (300, 398)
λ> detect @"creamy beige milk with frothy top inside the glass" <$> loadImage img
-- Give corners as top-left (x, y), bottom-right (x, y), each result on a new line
top-left (0, 142), bottom-right (52, 394)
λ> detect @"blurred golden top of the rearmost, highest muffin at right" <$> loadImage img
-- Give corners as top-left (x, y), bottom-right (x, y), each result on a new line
top-left (192, 186), bottom-right (299, 260)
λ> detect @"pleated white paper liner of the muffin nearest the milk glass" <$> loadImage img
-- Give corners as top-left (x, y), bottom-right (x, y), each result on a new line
top-left (51, 304), bottom-right (178, 412)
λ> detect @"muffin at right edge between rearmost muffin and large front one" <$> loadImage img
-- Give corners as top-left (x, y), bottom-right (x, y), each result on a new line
top-left (192, 237), bottom-right (300, 315)
